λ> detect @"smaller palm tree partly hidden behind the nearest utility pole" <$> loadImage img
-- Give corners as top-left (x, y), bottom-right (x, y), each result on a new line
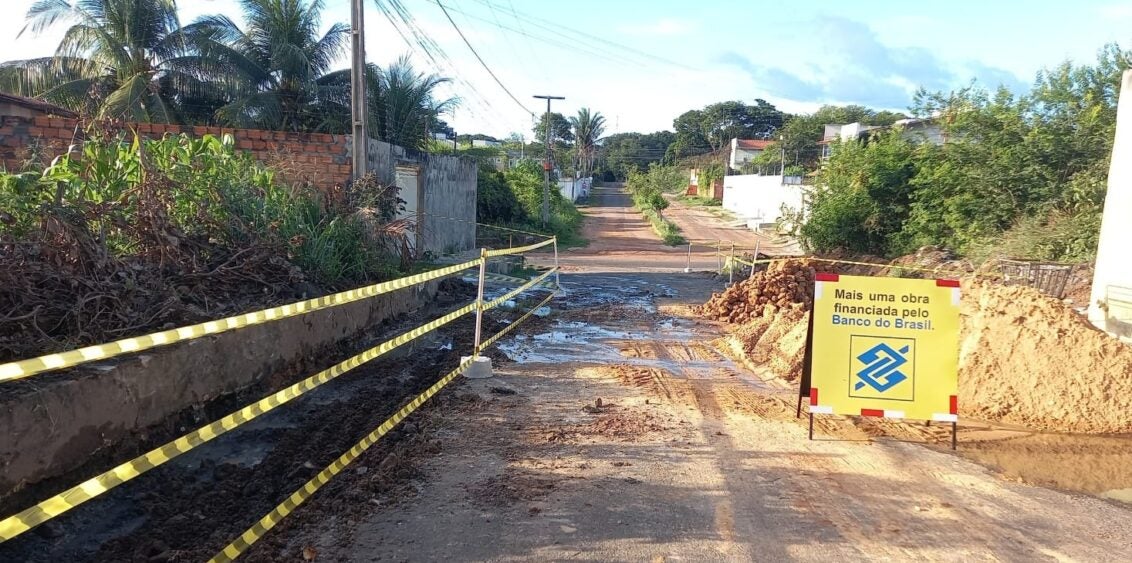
top-left (317, 57), bottom-right (458, 150)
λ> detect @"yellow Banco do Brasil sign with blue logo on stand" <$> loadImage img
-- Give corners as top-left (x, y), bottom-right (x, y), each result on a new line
top-left (809, 274), bottom-right (959, 421)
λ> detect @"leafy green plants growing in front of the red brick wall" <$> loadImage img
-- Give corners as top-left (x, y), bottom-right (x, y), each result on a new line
top-left (0, 131), bottom-right (396, 287)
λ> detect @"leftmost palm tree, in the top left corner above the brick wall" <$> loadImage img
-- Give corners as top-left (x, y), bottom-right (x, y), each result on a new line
top-left (0, 0), bottom-right (218, 121)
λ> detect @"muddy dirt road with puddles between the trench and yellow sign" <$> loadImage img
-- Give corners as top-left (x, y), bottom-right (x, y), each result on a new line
top-left (280, 185), bottom-right (1132, 561)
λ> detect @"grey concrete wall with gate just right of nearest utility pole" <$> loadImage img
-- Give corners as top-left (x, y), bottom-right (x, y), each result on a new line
top-left (367, 139), bottom-right (479, 255)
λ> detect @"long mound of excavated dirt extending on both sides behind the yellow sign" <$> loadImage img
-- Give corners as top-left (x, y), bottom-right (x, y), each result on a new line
top-left (698, 257), bottom-right (1132, 433)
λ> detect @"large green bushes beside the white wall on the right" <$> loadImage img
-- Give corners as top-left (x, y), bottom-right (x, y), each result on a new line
top-left (800, 45), bottom-right (1132, 261)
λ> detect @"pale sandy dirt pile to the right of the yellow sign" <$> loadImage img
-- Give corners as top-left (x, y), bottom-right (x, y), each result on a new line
top-left (959, 281), bottom-right (1132, 433)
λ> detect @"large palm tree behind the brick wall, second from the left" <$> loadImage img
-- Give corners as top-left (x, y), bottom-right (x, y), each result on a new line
top-left (186, 0), bottom-right (350, 130)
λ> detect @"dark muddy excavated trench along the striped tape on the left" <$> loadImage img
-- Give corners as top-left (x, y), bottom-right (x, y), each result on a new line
top-left (0, 282), bottom-right (525, 562)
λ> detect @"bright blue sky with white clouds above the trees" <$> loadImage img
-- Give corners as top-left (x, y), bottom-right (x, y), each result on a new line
top-left (0, 0), bottom-right (1132, 136)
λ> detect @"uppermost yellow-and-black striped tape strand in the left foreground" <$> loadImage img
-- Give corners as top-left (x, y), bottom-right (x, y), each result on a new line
top-left (0, 258), bottom-right (482, 383)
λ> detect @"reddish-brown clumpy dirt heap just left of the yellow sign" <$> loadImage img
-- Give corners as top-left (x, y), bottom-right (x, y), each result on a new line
top-left (700, 259), bottom-right (815, 323)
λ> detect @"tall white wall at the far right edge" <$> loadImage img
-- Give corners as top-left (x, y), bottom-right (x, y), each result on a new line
top-left (1089, 70), bottom-right (1132, 339)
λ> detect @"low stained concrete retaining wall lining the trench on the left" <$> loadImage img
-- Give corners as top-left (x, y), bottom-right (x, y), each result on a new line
top-left (0, 282), bottom-right (439, 498)
